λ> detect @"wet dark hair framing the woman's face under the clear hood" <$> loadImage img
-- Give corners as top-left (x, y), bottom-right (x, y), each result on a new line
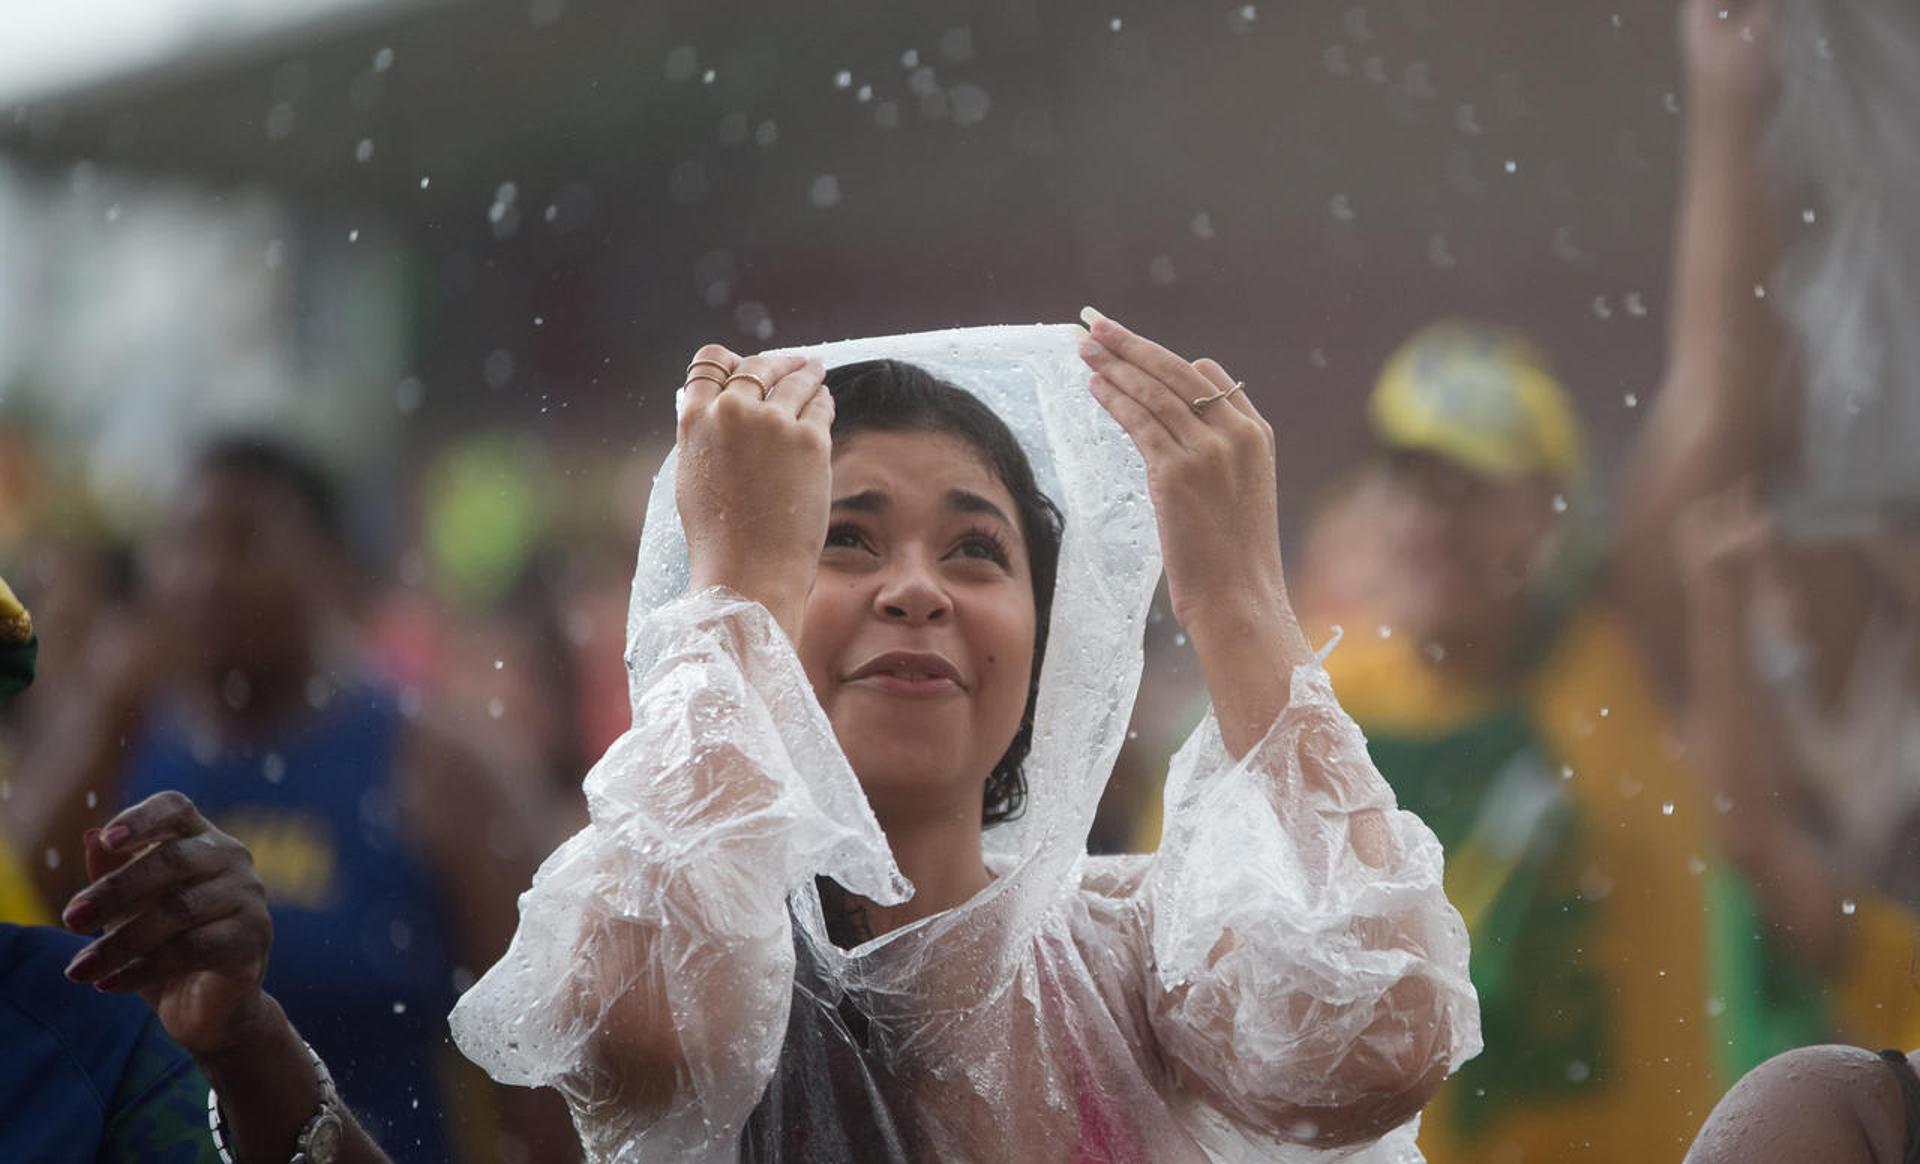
top-left (828, 359), bottom-right (1064, 826)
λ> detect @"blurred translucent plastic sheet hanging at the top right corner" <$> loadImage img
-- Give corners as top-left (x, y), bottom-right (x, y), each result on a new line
top-left (1770, 0), bottom-right (1920, 522)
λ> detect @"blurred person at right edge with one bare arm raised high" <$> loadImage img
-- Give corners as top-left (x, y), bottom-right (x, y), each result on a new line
top-left (1630, 4), bottom-right (1920, 1091)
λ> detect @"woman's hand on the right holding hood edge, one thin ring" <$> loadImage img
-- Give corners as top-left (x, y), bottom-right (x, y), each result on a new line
top-left (1081, 307), bottom-right (1286, 634)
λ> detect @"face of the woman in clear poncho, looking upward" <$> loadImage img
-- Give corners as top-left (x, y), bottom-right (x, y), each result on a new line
top-left (801, 432), bottom-right (1035, 822)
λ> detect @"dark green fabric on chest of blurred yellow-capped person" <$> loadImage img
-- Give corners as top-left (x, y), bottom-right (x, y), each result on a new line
top-left (1367, 707), bottom-right (1611, 1133)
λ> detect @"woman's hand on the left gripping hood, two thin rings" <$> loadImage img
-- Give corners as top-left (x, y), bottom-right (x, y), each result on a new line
top-left (674, 344), bottom-right (833, 642)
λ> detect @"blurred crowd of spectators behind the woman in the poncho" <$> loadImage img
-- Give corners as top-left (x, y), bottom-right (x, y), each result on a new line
top-left (0, 6), bottom-right (1920, 1162)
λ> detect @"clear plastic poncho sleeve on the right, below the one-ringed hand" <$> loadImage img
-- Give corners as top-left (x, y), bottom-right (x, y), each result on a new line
top-left (1139, 663), bottom-right (1480, 1158)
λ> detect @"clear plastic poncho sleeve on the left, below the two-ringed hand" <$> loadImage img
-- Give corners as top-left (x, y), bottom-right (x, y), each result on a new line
top-left (451, 590), bottom-right (908, 1160)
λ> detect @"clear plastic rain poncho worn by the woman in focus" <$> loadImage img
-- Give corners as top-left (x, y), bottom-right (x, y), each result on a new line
top-left (451, 327), bottom-right (1480, 1164)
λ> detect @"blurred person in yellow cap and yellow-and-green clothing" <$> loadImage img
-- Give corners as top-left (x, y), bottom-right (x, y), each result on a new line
top-left (1302, 323), bottom-right (1718, 1164)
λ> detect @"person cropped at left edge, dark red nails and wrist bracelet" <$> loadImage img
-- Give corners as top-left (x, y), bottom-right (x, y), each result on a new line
top-left (0, 580), bottom-right (386, 1164)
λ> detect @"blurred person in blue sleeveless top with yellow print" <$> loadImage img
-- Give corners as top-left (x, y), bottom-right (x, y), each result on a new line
top-left (15, 436), bottom-right (576, 1160)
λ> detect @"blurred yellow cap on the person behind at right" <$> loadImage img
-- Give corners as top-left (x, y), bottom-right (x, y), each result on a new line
top-left (1367, 319), bottom-right (1586, 486)
